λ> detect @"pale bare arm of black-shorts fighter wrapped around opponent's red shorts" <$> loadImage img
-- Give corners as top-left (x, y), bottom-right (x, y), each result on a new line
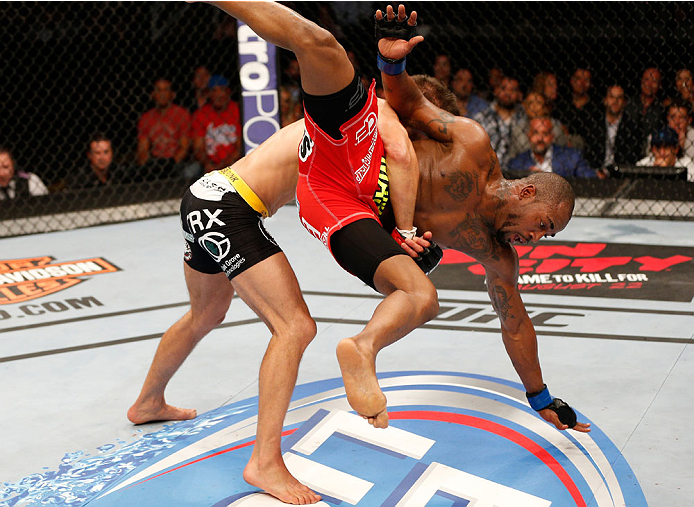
top-left (378, 100), bottom-right (419, 230)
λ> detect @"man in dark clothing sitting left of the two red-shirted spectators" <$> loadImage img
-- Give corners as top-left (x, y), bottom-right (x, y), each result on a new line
top-left (67, 132), bottom-right (131, 189)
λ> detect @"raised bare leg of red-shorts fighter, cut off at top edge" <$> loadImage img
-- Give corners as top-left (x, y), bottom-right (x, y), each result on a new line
top-left (201, 1), bottom-right (354, 95)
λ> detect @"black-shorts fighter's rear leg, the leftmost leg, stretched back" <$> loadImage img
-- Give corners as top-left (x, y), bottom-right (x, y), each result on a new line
top-left (128, 263), bottom-right (234, 424)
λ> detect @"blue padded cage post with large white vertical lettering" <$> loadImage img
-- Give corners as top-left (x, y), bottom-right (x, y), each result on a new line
top-left (238, 21), bottom-right (280, 154)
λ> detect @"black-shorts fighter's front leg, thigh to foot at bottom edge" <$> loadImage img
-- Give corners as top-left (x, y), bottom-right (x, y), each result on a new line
top-left (232, 253), bottom-right (320, 505)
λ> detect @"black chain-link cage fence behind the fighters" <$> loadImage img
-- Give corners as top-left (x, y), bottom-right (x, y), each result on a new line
top-left (0, 1), bottom-right (694, 236)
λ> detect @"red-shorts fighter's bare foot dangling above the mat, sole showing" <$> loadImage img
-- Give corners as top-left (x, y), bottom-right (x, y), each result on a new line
top-left (337, 338), bottom-right (388, 428)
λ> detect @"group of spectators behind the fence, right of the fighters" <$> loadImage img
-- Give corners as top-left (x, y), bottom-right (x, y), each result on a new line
top-left (431, 61), bottom-right (694, 181)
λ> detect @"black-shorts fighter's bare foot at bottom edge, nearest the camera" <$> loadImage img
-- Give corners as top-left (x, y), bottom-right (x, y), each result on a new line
top-left (243, 454), bottom-right (321, 505)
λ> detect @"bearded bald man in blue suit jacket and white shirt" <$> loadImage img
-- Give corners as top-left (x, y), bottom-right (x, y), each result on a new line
top-left (508, 116), bottom-right (596, 178)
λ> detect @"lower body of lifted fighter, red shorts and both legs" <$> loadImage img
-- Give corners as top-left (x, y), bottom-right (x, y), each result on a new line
top-left (196, 2), bottom-right (441, 434)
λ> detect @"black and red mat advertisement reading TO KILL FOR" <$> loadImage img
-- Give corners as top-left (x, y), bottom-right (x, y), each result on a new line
top-left (431, 241), bottom-right (694, 302)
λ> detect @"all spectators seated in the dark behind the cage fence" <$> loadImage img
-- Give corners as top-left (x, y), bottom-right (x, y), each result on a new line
top-left (0, 52), bottom-right (694, 204)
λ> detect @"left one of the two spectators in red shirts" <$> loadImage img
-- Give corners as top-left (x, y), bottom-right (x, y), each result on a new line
top-left (137, 75), bottom-right (190, 179)
